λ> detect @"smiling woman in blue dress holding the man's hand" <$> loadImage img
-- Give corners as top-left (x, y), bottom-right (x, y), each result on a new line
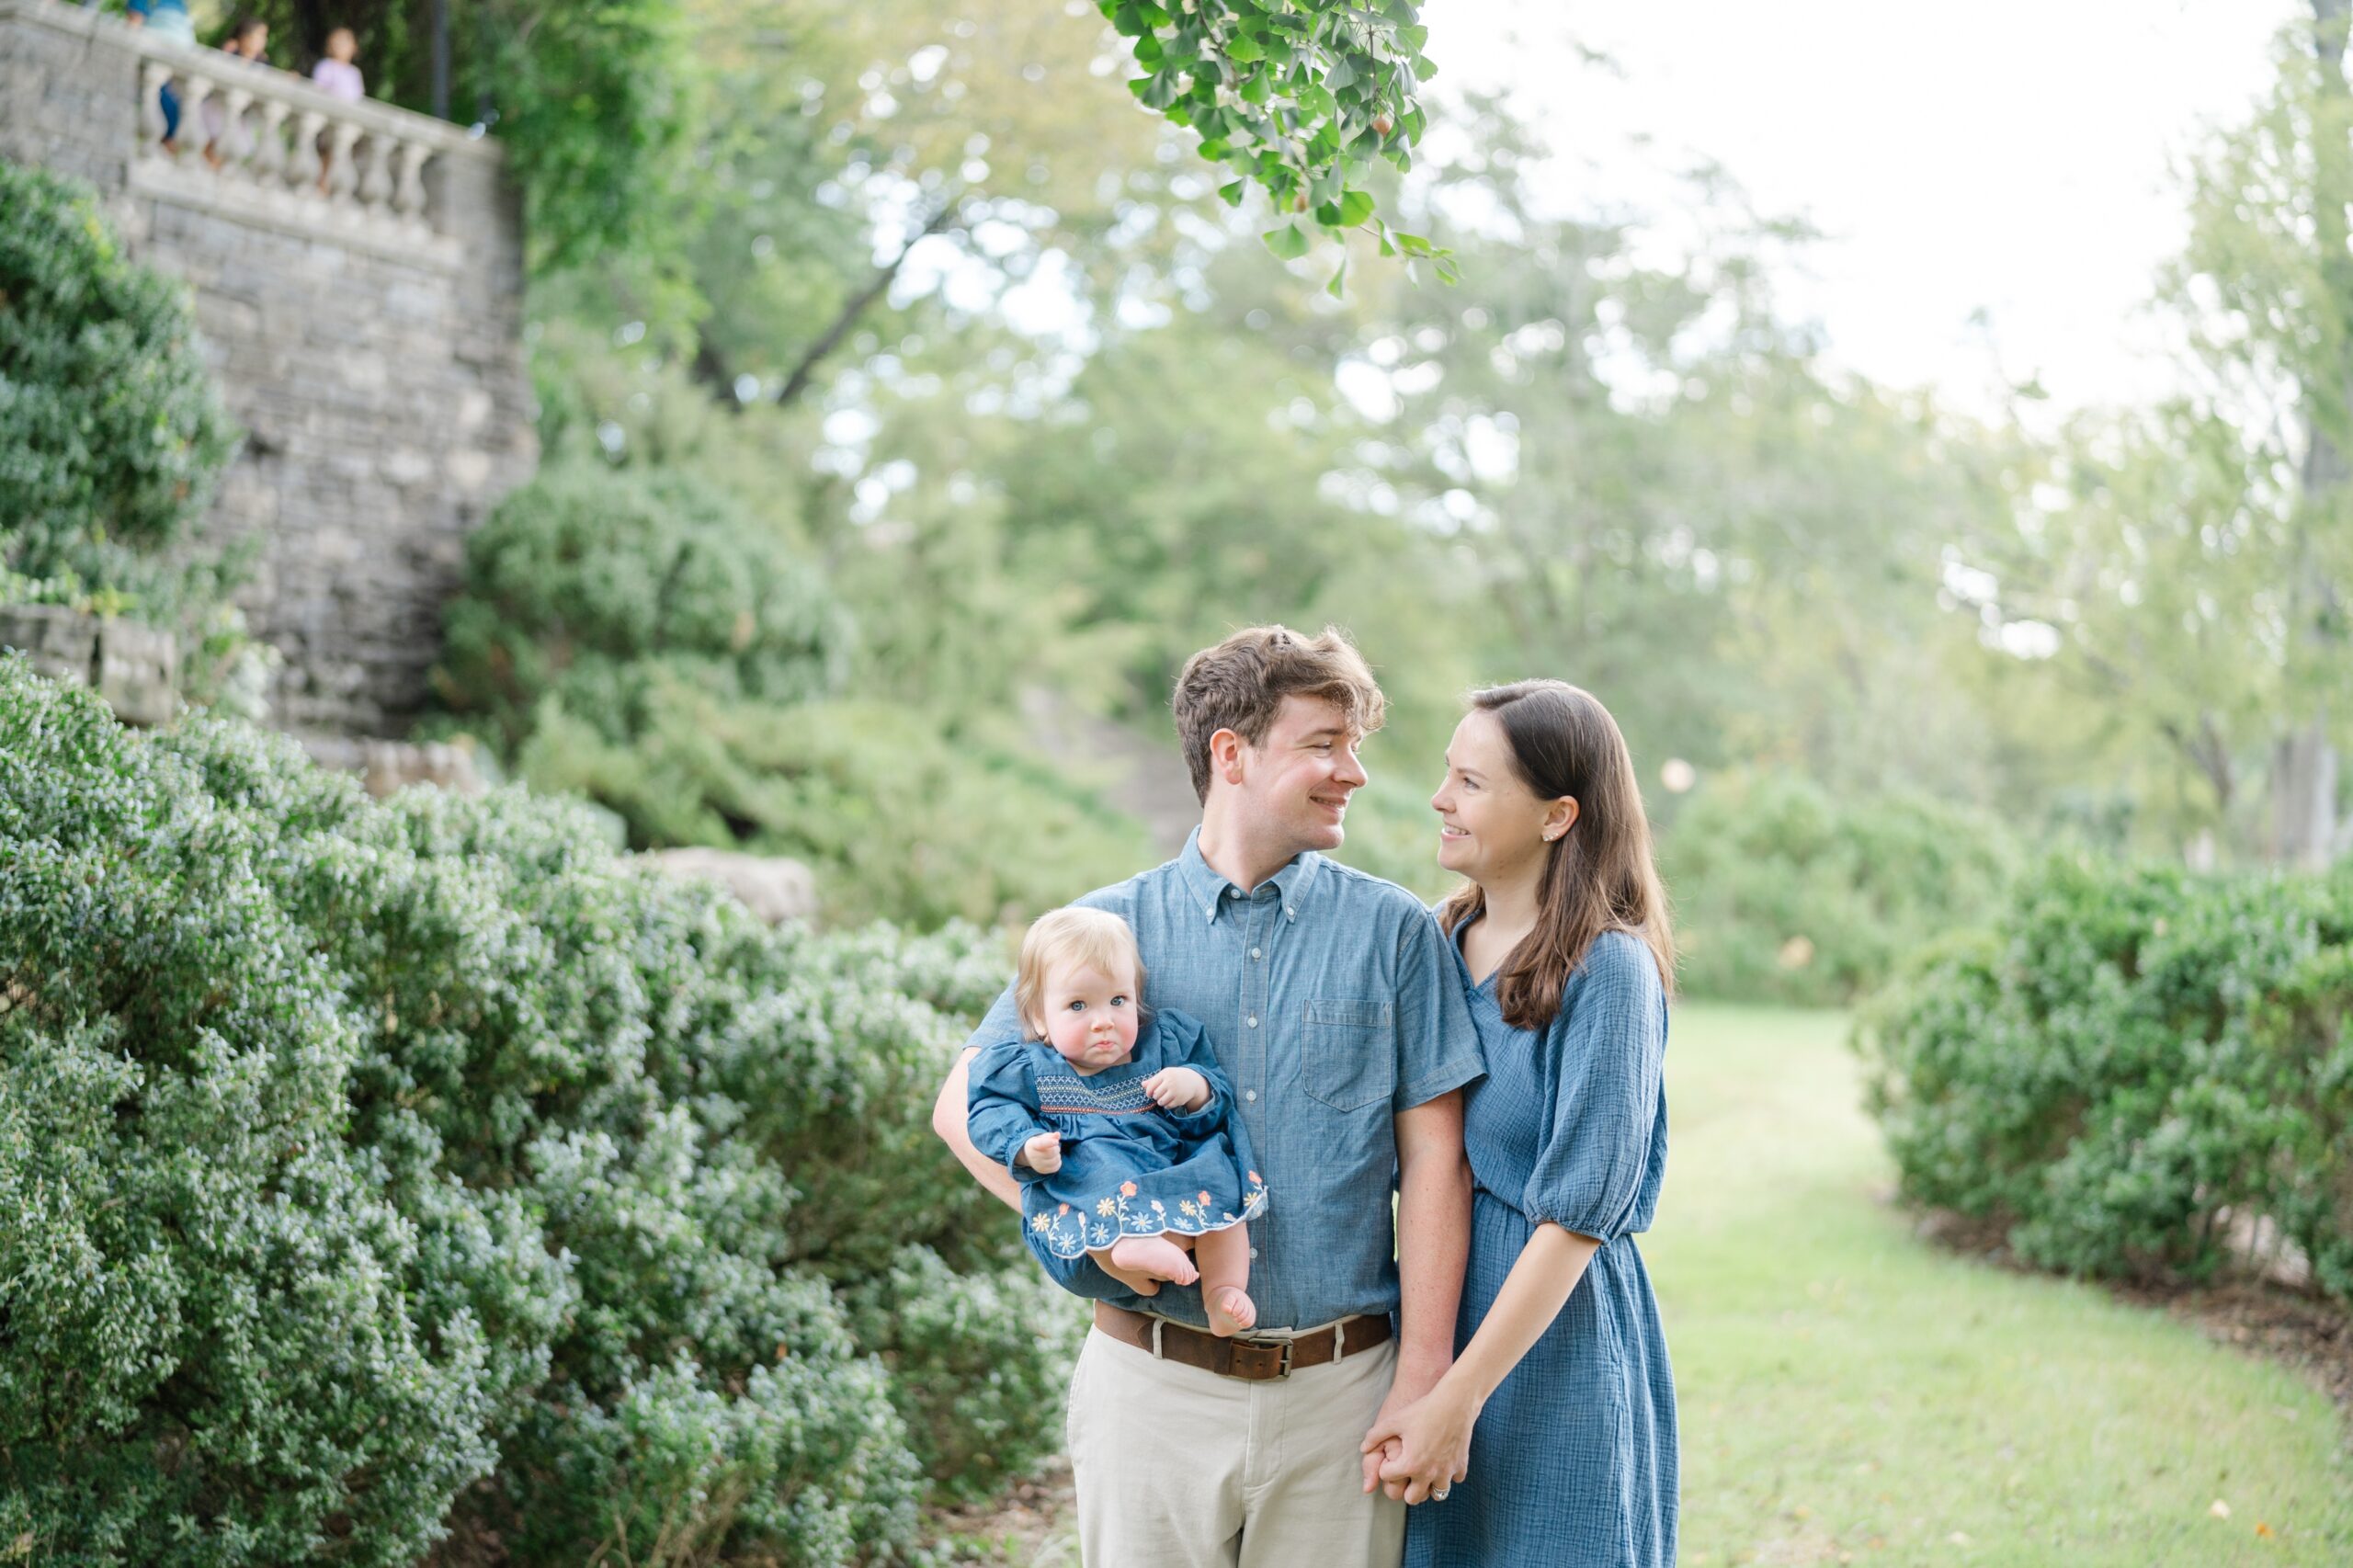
top-left (1365, 680), bottom-right (1677, 1568)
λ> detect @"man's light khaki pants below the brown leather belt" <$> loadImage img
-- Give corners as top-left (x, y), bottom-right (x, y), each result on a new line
top-left (1068, 1330), bottom-right (1404, 1568)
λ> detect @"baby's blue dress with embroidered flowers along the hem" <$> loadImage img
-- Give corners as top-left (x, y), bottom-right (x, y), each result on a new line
top-left (965, 1007), bottom-right (1266, 1259)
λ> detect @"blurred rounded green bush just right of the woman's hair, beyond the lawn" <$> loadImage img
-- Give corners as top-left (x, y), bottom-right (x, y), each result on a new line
top-left (1659, 772), bottom-right (2018, 1007)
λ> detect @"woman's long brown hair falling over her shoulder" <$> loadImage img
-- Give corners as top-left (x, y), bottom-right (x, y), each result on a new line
top-left (1438, 680), bottom-right (1676, 1028)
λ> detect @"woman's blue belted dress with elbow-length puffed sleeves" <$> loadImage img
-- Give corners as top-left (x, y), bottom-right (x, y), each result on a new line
top-left (1404, 930), bottom-right (1677, 1568)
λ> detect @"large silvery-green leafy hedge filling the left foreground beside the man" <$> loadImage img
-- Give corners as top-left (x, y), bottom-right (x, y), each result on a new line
top-left (0, 659), bottom-right (1068, 1565)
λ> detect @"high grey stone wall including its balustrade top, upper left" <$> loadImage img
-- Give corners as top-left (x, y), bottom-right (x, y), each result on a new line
top-left (0, 0), bottom-right (537, 734)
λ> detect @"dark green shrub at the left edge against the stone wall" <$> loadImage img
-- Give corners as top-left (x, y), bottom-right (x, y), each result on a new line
top-left (0, 160), bottom-right (233, 609)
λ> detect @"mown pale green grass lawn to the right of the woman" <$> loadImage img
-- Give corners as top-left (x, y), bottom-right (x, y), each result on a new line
top-left (1643, 1006), bottom-right (2353, 1568)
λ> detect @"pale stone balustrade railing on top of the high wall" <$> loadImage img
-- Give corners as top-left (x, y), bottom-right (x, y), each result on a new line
top-left (130, 28), bottom-right (487, 266)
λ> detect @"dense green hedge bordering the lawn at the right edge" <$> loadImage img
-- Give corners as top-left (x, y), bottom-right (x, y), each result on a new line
top-left (1859, 859), bottom-right (2353, 1300)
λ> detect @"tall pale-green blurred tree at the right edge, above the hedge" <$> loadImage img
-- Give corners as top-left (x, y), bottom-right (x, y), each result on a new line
top-left (1982, 12), bottom-right (2353, 867)
